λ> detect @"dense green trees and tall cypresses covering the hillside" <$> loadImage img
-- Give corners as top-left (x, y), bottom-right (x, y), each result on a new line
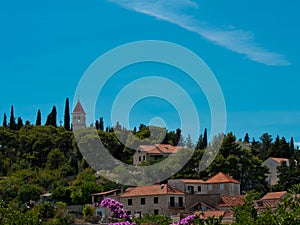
top-left (0, 103), bottom-right (300, 224)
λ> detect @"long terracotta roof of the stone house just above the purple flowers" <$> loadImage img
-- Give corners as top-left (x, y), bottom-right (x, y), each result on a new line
top-left (120, 184), bottom-right (184, 198)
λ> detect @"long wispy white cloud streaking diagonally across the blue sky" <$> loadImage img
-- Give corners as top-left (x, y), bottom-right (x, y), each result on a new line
top-left (108, 0), bottom-right (290, 66)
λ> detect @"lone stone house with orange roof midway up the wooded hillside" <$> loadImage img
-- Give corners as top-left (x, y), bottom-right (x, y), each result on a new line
top-left (133, 144), bottom-right (183, 165)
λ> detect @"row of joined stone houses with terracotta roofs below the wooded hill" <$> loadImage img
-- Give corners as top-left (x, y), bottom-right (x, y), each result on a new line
top-left (92, 172), bottom-right (240, 217)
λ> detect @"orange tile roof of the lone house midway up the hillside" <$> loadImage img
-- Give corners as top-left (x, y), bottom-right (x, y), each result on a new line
top-left (139, 144), bottom-right (183, 154)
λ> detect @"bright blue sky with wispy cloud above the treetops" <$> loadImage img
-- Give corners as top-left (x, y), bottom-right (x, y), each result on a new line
top-left (0, 0), bottom-right (300, 142)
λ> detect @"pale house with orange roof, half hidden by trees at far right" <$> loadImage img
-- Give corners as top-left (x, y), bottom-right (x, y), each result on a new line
top-left (262, 157), bottom-right (289, 186)
